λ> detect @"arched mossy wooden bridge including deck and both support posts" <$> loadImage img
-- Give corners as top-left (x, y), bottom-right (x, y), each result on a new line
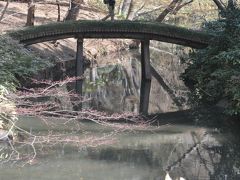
top-left (9, 20), bottom-right (213, 114)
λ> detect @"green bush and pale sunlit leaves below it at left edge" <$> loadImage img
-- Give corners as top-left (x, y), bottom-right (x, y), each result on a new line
top-left (0, 36), bottom-right (51, 132)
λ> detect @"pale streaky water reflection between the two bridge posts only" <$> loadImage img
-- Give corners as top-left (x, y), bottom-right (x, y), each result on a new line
top-left (85, 53), bottom-right (141, 113)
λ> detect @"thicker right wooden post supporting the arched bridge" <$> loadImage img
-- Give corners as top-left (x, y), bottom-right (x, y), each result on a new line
top-left (139, 40), bottom-right (152, 115)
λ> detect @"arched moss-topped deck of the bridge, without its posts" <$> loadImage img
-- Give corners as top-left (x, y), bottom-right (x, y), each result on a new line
top-left (9, 20), bottom-right (213, 48)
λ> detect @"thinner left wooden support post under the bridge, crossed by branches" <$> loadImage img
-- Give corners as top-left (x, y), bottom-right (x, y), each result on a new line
top-left (75, 38), bottom-right (84, 110)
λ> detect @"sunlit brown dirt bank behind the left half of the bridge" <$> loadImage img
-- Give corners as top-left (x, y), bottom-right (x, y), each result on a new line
top-left (0, 1), bottom-right (130, 63)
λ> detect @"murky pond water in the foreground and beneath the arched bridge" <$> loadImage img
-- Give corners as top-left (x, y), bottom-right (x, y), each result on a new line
top-left (0, 45), bottom-right (240, 180)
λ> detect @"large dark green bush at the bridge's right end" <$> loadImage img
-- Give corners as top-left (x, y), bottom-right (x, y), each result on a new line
top-left (183, 6), bottom-right (240, 116)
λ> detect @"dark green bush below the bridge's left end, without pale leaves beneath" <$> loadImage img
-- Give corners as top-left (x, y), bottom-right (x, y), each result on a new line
top-left (0, 36), bottom-right (51, 90)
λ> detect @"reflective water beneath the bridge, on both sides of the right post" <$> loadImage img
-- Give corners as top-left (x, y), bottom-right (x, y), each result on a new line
top-left (81, 46), bottom-right (188, 113)
